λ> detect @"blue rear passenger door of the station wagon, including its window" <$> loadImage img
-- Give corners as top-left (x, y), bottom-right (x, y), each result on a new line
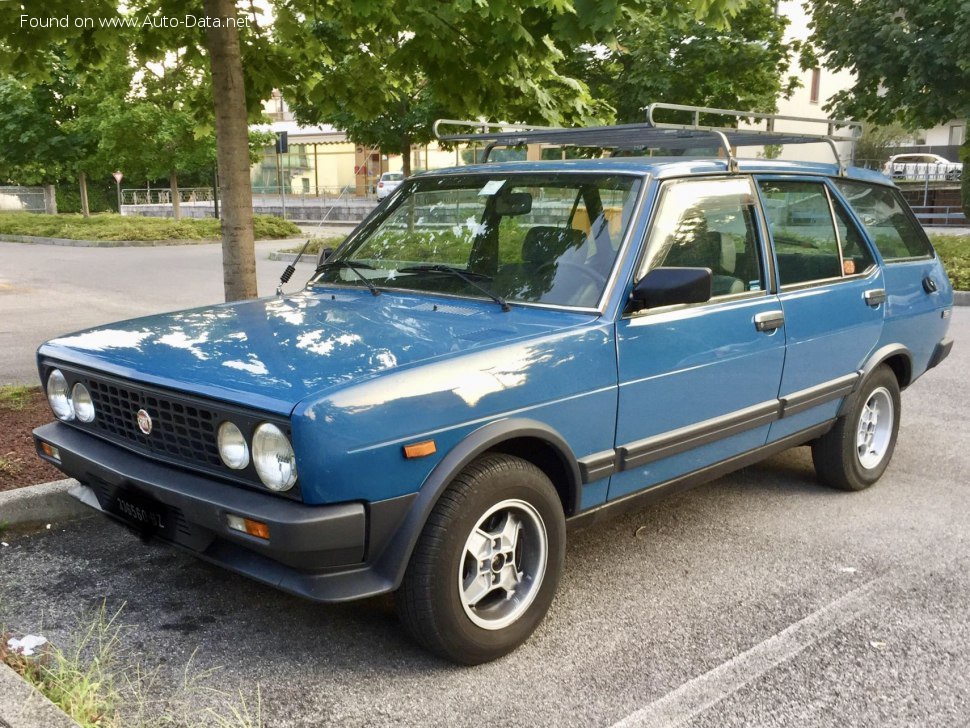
top-left (758, 177), bottom-right (886, 441)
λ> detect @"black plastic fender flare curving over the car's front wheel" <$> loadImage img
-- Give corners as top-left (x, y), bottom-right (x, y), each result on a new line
top-left (375, 418), bottom-right (581, 589)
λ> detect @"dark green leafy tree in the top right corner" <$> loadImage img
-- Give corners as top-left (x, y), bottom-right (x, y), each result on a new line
top-left (803, 0), bottom-right (970, 216)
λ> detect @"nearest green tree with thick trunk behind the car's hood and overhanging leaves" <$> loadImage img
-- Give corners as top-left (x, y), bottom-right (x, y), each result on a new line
top-left (0, 0), bottom-right (743, 299)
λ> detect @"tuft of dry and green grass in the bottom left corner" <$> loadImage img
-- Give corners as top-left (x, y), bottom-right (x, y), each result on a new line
top-left (0, 603), bottom-right (264, 728)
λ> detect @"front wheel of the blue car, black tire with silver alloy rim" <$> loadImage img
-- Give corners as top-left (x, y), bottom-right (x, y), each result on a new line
top-left (396, 454), bottom-right (566, 665)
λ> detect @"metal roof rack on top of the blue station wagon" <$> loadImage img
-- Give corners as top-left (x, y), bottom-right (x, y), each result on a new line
top-left (433, 103), bottom-right (863, 175)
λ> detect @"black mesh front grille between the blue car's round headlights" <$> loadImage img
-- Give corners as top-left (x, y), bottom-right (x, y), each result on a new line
top-left (87, 378), bottom-right (222, 467)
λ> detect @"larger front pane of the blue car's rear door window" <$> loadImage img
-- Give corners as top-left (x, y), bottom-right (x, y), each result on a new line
top-left (759, 180), bottom-right (842, 286)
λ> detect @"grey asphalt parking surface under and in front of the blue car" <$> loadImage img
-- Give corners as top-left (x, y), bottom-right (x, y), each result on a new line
top-left (0, 308), bottom-right (970, 728)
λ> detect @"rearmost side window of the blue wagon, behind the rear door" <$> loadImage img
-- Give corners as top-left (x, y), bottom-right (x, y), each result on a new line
top-left (835, 180), bottom-right (933, 261)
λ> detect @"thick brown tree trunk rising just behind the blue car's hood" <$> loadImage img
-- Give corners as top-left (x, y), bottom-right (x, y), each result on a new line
top-left (205, 0), bottom-right (256, 301)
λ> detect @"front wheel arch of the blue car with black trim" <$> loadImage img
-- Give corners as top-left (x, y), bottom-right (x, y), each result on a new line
top-left (375, 418), bottom-right (582, 589)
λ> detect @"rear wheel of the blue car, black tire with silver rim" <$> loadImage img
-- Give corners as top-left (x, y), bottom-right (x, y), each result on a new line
top-left (812, 365), bottom-right (902, 490)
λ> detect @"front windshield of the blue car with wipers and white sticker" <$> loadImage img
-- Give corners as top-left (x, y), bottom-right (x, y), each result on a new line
top-left (310, 173), bottom-right (641, 308)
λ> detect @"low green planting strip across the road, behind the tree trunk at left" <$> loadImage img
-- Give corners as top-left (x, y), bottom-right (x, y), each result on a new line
top-left (0, 212), bottom-right (300, 241)
